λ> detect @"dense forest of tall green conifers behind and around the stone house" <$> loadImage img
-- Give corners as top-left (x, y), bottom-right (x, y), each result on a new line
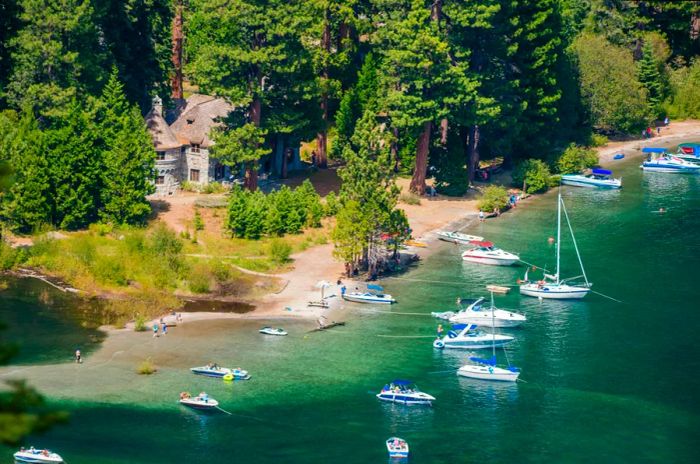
top-left (0, 0), bottom-right (700, 236)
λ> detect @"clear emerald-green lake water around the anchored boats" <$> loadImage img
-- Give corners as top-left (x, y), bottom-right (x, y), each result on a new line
top-left (0, 161), bottom-right (700, 464)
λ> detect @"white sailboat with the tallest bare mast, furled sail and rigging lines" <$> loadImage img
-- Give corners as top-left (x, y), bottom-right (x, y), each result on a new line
top-left (519, 190), bottom-right (593, 300)
